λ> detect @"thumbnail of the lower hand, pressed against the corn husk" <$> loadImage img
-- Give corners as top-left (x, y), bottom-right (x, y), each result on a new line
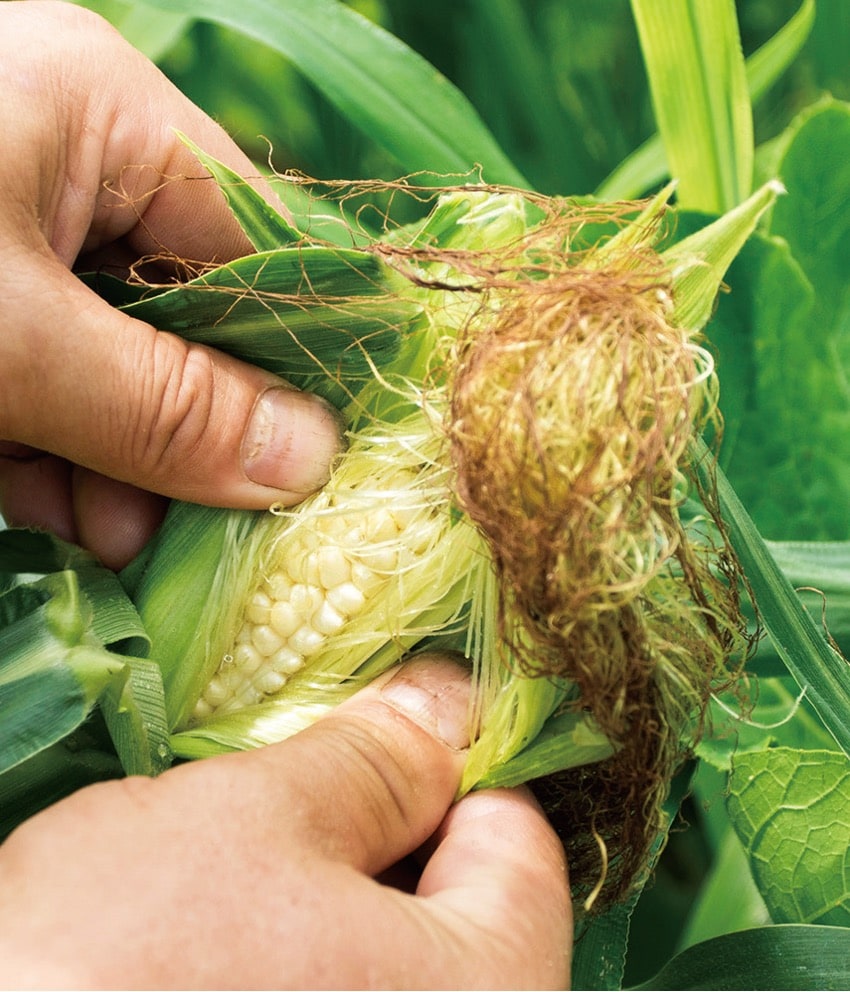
top-left (381, 655), bottom-right (472, 751)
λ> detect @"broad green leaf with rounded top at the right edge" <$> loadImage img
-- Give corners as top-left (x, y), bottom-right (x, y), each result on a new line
top-left (709, 100), bottom-right (850, 541)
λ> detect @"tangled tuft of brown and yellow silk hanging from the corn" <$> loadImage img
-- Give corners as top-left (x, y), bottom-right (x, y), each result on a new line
top-left (368, 201), bottom-right (749, 906)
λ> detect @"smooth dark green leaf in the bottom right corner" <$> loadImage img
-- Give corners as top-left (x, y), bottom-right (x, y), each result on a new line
top-left (634, 924), bottom-right (850, 992)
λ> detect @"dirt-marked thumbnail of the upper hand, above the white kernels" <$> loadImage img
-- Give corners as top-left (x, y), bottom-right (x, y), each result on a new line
top-left (242, 387), bottom-right (342, 496)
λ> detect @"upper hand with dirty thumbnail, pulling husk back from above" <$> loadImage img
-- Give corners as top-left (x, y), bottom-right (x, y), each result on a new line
top-left (0, 0), bottom-right (339, 567)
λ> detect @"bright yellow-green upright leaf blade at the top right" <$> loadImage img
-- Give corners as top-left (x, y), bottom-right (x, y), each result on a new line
top-left (632, 0), bottom-right (754, 214)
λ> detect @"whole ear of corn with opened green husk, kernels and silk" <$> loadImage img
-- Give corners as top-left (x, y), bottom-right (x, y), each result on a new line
top-left (114, 157), bottom-right (778, 900)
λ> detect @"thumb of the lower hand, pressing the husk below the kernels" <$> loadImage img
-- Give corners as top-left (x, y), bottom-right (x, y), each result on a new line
top-left (270, 653), bottom-right (470, 876)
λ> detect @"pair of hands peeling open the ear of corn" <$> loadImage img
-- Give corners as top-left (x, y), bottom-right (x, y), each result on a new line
top-left (0, 0), bottom-right (572, 988)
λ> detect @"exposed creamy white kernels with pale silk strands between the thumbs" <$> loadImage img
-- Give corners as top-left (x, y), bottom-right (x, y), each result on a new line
top-left (190, 414), bottom-right (482, 724)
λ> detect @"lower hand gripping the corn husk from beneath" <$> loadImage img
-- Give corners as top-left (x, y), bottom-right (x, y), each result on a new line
top-left (0, 656), bottom-right (572, 989)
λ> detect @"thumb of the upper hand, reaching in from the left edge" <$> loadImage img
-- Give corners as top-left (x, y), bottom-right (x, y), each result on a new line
top-left (0, 252), bottom-right (340, 508)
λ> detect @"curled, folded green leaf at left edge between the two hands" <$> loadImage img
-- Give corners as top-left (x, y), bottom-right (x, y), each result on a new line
top-left (0, 544), bottom-right (170, 774)
